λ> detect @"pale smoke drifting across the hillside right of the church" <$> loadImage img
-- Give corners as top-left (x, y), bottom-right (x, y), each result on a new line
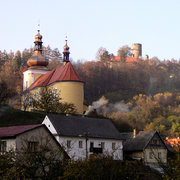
top-left (85, 98), bottom-right (129, 115)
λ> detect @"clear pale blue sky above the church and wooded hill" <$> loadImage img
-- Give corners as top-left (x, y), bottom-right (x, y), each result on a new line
top-left (0, 0), bottom-right (180, 61)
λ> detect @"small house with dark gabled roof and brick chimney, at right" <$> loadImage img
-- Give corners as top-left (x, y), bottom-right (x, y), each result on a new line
top-left (122, 131), bottom-right (168, 167)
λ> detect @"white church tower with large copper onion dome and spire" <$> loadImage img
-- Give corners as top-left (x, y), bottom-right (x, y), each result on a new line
top-left (23, 30), bottom-right (48, 91)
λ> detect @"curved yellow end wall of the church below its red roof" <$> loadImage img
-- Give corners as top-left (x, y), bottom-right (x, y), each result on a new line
top-left (49, 81), bottom-right (84, 114)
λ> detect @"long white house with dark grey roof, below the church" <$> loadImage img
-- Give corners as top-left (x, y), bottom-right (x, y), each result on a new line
top-left (42, 114), bottom-right (123, 160)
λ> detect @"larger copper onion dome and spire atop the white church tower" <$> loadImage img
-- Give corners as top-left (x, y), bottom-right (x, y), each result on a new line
top-left (27, 30), bottom-right (48, 67)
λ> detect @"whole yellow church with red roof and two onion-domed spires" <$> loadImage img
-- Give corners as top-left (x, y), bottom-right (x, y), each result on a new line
top-left (23, 30), bottom-right (84, 114)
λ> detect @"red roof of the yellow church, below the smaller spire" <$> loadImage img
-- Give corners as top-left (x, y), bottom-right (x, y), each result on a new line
top-left (28, 62), bottom-right (83, 90)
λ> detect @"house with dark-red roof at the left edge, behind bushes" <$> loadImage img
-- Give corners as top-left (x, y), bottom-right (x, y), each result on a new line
top-left (0, 124), bottom-right (69, 160)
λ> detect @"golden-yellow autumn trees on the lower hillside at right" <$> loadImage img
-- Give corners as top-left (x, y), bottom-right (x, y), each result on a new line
top-left (120, 92), bottom-right (180, 137)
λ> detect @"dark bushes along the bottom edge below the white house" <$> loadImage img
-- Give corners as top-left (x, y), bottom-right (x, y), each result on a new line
top-left (62, 156), bottom-right (161, 180)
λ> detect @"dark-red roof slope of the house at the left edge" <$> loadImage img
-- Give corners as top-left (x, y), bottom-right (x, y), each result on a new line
top-left (0, 124), bottom-right (42, 138)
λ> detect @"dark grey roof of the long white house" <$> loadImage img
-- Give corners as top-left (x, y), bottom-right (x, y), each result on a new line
top-left (47, 114), bottom-right (122, 139)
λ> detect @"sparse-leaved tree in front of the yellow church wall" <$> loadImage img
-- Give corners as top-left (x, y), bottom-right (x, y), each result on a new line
top-left (24, 87), bottom-right (76, 114)
